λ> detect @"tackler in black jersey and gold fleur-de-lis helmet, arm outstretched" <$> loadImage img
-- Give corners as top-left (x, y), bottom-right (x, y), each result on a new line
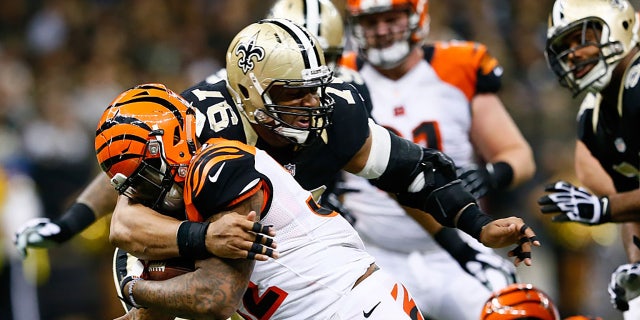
top-left (15, 20), bottom-right (539, 290)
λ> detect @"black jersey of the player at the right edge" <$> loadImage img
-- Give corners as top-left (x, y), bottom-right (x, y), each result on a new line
top-left (578, 55), bottom-right (640, 192)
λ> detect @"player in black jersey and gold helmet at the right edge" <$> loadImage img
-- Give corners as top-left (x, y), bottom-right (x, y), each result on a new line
top-left (538, 0), bottom-right (640, 319)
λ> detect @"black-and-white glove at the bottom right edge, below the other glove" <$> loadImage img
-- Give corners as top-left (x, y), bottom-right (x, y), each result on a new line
top-left (608, 262), bottom-right (640, 311)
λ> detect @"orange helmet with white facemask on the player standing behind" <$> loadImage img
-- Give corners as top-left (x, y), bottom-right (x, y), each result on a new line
top-left (347, 0), bottom-right (429, 69)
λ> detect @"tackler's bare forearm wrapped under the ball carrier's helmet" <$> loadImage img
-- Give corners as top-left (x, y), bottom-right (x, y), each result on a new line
top-left (109, 196), bottom-right (181, 260)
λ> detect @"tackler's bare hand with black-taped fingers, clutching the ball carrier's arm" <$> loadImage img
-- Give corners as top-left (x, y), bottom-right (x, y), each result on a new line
top-left (206, 211), bottom-right (279, 261)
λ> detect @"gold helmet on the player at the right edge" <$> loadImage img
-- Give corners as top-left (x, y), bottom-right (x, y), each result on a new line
top-left (545, 0), bottom-right (638, 96)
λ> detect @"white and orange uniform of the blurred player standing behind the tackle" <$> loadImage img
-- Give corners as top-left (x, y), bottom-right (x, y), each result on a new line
top-left (343, 42), bottom-right (508, 320)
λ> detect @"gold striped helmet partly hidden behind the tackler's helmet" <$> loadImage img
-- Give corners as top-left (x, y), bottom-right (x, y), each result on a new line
top-left (267, 0), bottom-right (344, 68)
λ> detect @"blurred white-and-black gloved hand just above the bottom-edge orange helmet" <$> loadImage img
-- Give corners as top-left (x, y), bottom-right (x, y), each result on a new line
top-left (453, 240), bottom-right (516, 292)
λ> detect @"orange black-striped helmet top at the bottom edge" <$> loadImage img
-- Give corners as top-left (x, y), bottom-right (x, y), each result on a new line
top-left (480, 283), bottom-right (560, 320)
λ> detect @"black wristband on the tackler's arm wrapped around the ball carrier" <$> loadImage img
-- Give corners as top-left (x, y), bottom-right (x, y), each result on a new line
top-left (178, 221), bottom-right (212, 260)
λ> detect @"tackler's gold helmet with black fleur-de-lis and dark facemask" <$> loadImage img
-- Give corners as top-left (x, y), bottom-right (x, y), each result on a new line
top-left (226, 19), bottom-right (334, 145)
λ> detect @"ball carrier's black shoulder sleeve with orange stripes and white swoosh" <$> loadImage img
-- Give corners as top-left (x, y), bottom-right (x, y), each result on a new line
top-left (184, 139), bottom-right (267, 219)
